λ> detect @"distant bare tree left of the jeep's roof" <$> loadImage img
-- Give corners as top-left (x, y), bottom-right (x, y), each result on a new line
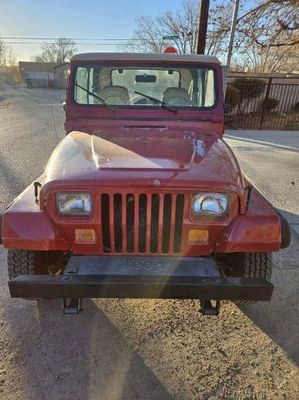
top-left (34, 38), bottom-right (77, 63)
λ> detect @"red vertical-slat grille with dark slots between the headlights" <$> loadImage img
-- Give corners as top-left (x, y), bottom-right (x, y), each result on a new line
top-left (100, 193), bottom-right (185, 254)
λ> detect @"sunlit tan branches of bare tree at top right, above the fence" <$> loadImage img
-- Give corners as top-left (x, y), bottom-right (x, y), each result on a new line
top-left (234, 0), bottom-right (299, 72)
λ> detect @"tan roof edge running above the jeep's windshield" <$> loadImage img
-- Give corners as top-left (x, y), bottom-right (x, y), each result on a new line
top-left (71, 53), bottom-right (220, 64)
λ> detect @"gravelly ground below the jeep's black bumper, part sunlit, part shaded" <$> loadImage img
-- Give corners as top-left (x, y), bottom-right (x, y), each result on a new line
top-left (0, 234), bottom-right (299, 400)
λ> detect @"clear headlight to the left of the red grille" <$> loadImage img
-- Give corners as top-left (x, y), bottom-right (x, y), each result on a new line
top-left (56, 193), bottom-right (92, 215)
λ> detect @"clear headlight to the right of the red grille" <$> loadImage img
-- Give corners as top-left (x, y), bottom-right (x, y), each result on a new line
top-left (192, 193), bottom-right (229, 217)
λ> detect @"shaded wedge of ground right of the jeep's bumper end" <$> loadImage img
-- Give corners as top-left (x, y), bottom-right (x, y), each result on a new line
top-left (239, 222), bottom-right (299, 365)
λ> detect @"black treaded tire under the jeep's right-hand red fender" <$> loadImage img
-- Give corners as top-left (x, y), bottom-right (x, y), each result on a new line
top-left (218, 253), bottom-right (272, 304)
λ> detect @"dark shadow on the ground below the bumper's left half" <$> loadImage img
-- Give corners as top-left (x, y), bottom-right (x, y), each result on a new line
top-left (3, 299), bottom-right (172, 400)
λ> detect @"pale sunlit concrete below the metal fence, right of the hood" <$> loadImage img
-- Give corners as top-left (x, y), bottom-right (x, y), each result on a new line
top-left (224, 130), bottom-right (299, 233)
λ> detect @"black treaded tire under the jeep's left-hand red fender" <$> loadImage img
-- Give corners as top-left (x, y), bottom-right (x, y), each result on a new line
top-left (7, 250), bottom-right (47, 279)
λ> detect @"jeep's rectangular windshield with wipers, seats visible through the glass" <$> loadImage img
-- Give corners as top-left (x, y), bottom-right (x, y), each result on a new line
top-left (74, 64), bottom-right (215, 110)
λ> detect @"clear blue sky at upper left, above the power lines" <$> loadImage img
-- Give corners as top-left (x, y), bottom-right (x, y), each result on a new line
top-left (0, 0), bottom-right (181, 60)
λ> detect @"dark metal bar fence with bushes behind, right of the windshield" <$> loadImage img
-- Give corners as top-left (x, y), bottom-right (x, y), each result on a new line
top-left (225, 77), bottom-right (299, 130)
